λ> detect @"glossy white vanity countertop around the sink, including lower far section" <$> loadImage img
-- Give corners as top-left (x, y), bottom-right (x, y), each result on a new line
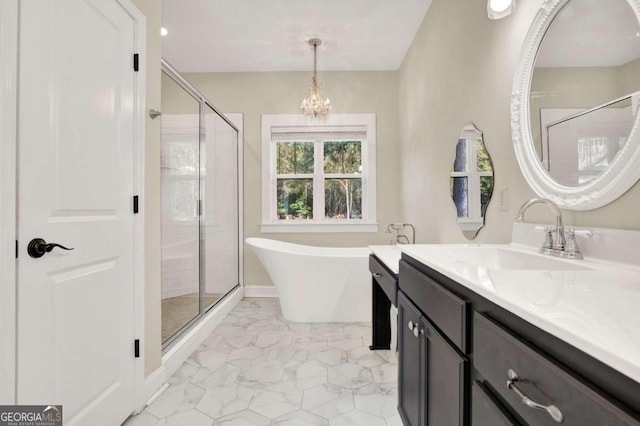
top-left (402, 244), bottom-right (640, 383)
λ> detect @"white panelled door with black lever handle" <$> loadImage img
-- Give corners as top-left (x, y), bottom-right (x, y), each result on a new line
top-left (17, 0), bottom-right (135, 425)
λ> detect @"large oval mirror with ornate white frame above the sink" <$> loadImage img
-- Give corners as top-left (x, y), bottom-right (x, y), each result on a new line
top-left (511, 0), bottom-right (640, 210)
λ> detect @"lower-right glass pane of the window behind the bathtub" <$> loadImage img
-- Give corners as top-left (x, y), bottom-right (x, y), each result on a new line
top-left (324, 179), bottom-right (362, 219)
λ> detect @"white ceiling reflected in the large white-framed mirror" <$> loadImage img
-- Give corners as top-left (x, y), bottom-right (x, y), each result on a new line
top-left (536, 0), bottom-right (640, 67)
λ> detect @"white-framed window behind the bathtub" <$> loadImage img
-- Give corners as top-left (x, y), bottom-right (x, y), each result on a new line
top-left (261, 114), bottom-right (377, 232)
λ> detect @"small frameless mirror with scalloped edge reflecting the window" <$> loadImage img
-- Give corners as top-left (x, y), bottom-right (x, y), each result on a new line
top-left (449, 123), bottom-right (493, 239)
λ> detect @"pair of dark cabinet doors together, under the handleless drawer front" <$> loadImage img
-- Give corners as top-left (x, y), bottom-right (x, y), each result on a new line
top-left (398, 291), bottom-right (469, 426)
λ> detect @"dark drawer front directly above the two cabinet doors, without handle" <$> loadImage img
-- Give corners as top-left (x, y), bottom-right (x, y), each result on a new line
top-left (398, 261), bottom-right (470, 353)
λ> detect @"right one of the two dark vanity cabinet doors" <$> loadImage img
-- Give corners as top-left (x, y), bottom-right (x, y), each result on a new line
top-left (424, 318), bottom-right (469, 426)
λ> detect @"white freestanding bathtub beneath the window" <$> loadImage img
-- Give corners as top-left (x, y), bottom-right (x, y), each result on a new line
top-left (246, 238), bottom-right (371, 322)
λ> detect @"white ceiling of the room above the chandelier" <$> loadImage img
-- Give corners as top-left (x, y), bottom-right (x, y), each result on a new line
top-left (162, 0), bottom-right (431, 72)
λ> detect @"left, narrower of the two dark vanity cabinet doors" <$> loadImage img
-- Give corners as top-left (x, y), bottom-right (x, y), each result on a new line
top-left (398, 292), bottom-right (426, 426)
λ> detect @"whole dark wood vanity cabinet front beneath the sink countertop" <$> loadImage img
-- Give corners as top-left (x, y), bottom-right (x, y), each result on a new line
top-left (397, 255), bottom-right (640, 426)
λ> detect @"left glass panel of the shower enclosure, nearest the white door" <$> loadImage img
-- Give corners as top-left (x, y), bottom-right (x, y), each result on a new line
top-left (160, 72), bottom-right (204, 347)
